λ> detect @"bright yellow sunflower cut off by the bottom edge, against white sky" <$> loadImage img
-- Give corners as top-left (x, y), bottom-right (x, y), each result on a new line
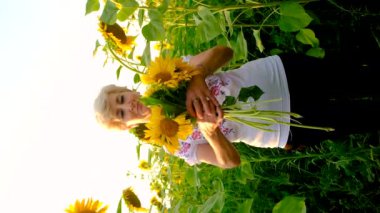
top-left (65, 198), bottom-right (108, 213)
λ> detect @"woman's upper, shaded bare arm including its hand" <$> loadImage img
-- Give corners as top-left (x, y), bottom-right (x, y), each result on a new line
top-left (186, 46), bottom-right (233, 118)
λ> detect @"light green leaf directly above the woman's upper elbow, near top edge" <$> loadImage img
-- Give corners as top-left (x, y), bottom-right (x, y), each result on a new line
top-left (194, 6), bottom-right (223, 43)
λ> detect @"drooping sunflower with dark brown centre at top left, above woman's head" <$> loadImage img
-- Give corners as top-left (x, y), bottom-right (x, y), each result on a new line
top-left (99, 21), bottom-right (136, 55)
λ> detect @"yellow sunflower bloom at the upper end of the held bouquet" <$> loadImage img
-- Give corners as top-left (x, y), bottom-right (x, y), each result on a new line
top-left (141, 56), bottom-right (198, 88)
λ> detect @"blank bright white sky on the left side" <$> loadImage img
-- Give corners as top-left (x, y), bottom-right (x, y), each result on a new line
top-left (0, 0), bottom-right (154, 213)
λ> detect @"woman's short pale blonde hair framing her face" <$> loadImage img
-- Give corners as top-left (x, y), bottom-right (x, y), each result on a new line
top-left (94, 84), bottom-right (131, 130)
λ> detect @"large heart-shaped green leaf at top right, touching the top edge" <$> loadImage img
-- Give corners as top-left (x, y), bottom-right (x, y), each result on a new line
top-left (278, 1), bottom-right (313, 32)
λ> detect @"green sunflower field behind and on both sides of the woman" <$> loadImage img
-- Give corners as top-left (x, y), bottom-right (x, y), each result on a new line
top-left (86, 0), bottom-right (380, 213)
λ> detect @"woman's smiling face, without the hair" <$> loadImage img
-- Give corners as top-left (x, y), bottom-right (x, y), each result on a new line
top-left (108, 91), bottom-right (150, 127)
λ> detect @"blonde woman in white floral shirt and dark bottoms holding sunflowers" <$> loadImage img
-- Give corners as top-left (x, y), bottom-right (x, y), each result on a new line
top-left (95, 46), bottom-right (380, 168)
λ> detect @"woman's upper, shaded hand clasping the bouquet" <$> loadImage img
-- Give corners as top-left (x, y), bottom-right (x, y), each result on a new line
top-left (186, 75), bottom-right (220, 119)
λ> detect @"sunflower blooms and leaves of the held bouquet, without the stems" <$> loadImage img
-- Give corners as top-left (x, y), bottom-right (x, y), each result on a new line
top-left (131, 57), bottom-right (198, 153)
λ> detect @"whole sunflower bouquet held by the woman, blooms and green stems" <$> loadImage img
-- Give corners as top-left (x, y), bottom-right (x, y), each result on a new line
top-left (131, 56), bottom-right (333, 153)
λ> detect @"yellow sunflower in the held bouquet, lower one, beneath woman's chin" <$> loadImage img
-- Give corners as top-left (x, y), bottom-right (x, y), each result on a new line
top-left (145, 106), bottom-right (193, 153)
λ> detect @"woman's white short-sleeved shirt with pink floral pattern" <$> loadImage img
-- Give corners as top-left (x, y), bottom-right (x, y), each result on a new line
top-left (175, 56), bottom-right (290, 165)
